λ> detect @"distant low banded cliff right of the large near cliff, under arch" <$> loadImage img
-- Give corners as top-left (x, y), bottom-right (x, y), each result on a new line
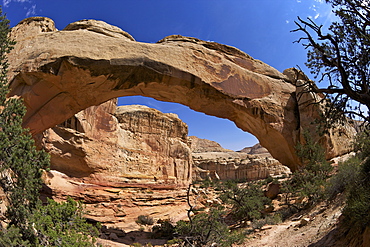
top-left (190, 136), bottom-right (291, 181)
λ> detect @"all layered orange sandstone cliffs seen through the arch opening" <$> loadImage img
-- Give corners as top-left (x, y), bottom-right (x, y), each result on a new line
top-left (38, 102), bottom-right (289, 230)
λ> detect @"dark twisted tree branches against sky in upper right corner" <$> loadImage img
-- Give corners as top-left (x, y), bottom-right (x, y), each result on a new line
top-left (294, 0), bottom-right (370, 123)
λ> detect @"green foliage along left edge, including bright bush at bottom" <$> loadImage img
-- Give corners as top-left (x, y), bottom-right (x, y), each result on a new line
top-left (0, 8), bottom-right (97, 246)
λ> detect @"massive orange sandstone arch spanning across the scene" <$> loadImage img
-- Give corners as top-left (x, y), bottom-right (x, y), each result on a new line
top-left (5, 17), bottom-right (352, 172)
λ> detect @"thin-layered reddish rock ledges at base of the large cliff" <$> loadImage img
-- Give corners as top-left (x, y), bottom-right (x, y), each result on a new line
top-left (43, 170), bottom-right (188, 227)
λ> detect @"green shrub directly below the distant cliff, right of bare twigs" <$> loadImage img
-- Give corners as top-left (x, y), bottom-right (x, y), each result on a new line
top-left (216, 181), bottom-right (271, 221)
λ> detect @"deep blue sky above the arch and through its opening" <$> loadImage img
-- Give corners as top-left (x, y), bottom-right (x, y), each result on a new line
top-left (2, 0), bottom-right (334, 150)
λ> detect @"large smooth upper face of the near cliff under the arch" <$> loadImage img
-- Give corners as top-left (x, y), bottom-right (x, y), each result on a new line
top-left (41, 100), bottom-right (192, 186)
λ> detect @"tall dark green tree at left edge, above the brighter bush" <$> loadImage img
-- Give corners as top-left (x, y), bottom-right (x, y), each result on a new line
top-left (0, 5), bottom-right (49, 242)
